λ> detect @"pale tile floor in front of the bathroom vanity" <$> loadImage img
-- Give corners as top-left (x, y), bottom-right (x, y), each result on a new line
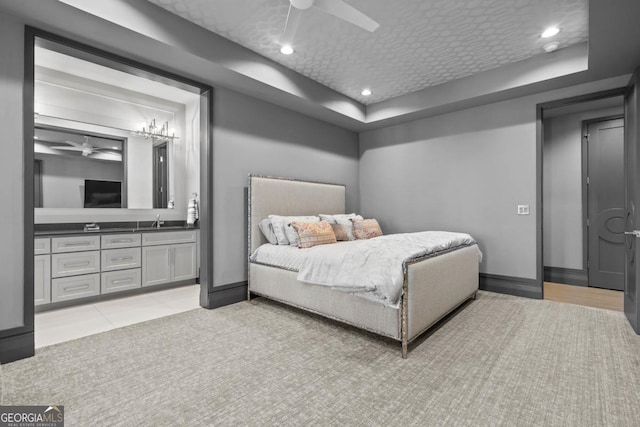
top-left (35, 284), bottom-right (200, 348)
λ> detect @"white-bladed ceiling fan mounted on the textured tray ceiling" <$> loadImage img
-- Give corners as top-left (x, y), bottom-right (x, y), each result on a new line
top-left (280, 0), bottom-right (380, 45)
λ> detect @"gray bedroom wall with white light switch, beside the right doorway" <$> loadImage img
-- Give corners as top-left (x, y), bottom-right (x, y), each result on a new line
top-left (360, 98), bottom-right (536, 279)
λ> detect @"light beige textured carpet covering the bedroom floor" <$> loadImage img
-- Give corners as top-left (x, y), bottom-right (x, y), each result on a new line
top-left (0, 292), bottom-right (640, 426)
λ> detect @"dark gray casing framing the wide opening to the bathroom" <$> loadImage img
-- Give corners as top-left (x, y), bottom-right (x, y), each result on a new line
top-left (9, 27), bottom-right (213, 363)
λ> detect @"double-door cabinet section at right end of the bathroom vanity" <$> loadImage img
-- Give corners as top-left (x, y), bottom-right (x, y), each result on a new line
top-left (142, 230), bottom-right (197, 286)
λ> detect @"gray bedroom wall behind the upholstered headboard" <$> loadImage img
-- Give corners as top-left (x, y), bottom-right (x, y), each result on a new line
top-left (213, 89), bottom-right (359, 286)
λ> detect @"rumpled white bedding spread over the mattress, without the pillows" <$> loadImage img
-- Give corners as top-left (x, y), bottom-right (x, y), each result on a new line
top-left (250, 231), bottom-right (481, 307)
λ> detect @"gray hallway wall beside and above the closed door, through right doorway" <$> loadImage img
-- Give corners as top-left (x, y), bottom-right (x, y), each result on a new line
top-left (543, 105), bottom-right (623, 270)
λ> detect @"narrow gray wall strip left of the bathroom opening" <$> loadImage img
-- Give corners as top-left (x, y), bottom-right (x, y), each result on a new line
top-left (0, 14), bottom-right (24, 330)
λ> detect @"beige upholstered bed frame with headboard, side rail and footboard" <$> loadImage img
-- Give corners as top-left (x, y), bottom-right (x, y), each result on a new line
top-left (248, 175), bottom-right (480, 358)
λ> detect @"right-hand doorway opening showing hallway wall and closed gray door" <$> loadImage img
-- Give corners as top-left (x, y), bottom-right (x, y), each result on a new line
top-left (541, 91), bottom-right (624, 300)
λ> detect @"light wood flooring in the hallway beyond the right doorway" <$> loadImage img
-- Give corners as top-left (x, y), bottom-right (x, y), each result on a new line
top-left (544, 282), bottom-right (624, 311)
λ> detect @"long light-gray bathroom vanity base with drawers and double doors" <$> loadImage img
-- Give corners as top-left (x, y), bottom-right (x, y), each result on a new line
top-left (34, 225), bottom-right (199, 309)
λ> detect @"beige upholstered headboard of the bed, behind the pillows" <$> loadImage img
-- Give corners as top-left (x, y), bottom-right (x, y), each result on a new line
top-left (249, 175), bottom-right (347, 254)
